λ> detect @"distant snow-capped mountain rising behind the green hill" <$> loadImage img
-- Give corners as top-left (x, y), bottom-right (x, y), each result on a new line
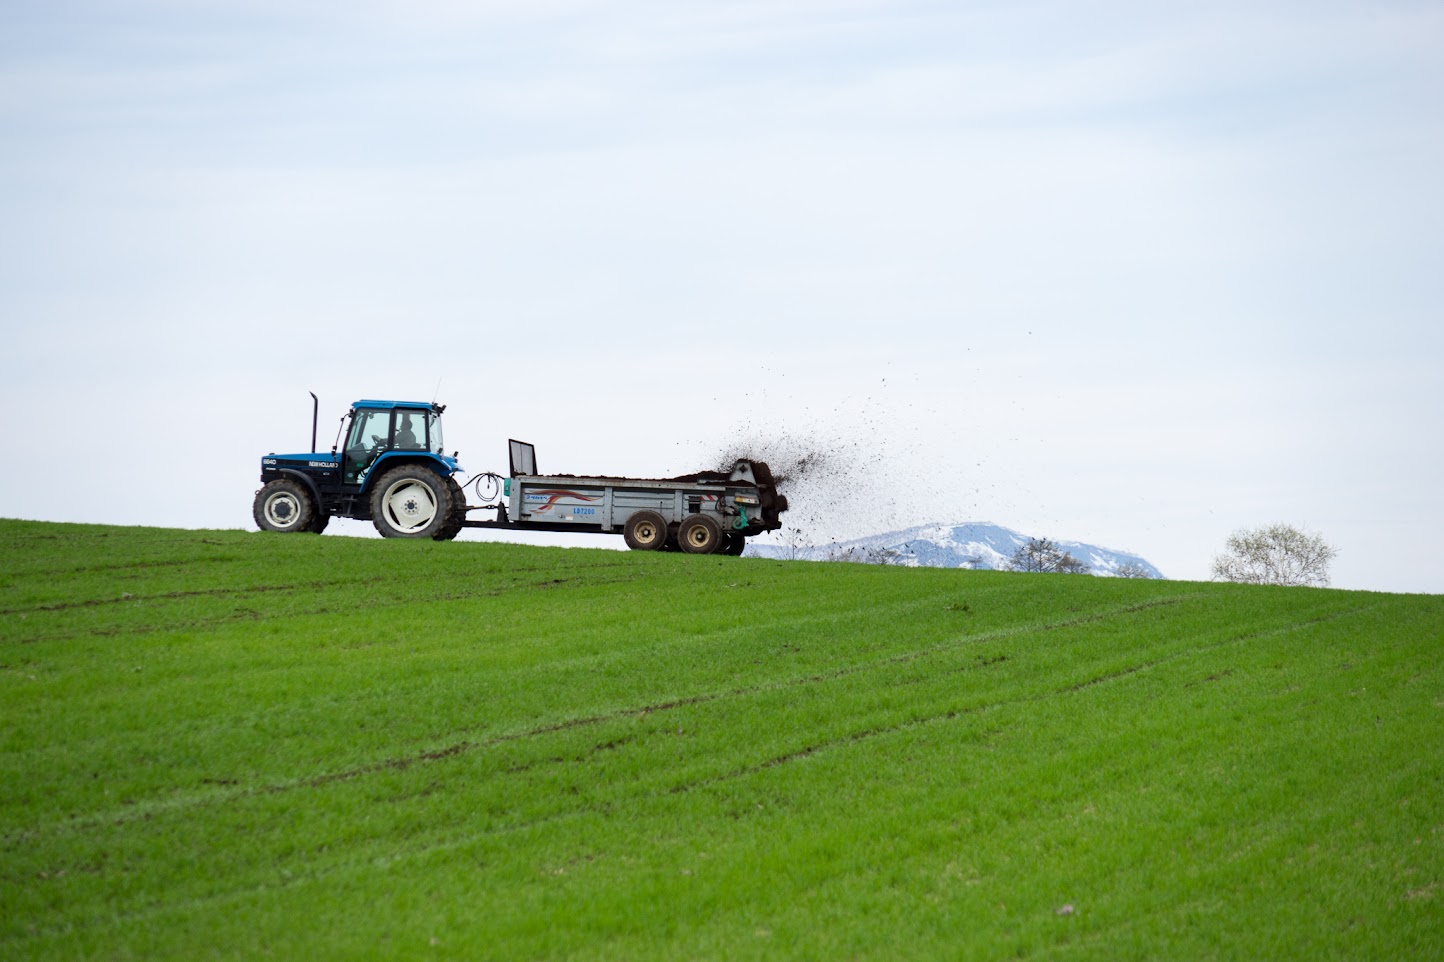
top-left (747, 521), bottom-right (1164, 578)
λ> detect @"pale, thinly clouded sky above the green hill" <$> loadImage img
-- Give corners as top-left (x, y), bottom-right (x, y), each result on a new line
top-left (0, 0), bottom-right (1444, 592)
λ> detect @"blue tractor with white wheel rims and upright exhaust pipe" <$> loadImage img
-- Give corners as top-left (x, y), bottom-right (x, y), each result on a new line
top-left (251, 394), bottom-right (466, 540)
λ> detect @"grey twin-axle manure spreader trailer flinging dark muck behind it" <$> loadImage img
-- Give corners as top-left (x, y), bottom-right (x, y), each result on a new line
top-left (465, 441), bottom-right (787, 555)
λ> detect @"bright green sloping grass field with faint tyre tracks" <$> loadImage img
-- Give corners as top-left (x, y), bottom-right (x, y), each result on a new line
top-left (0, 521), bottom-right (1444, 961)
